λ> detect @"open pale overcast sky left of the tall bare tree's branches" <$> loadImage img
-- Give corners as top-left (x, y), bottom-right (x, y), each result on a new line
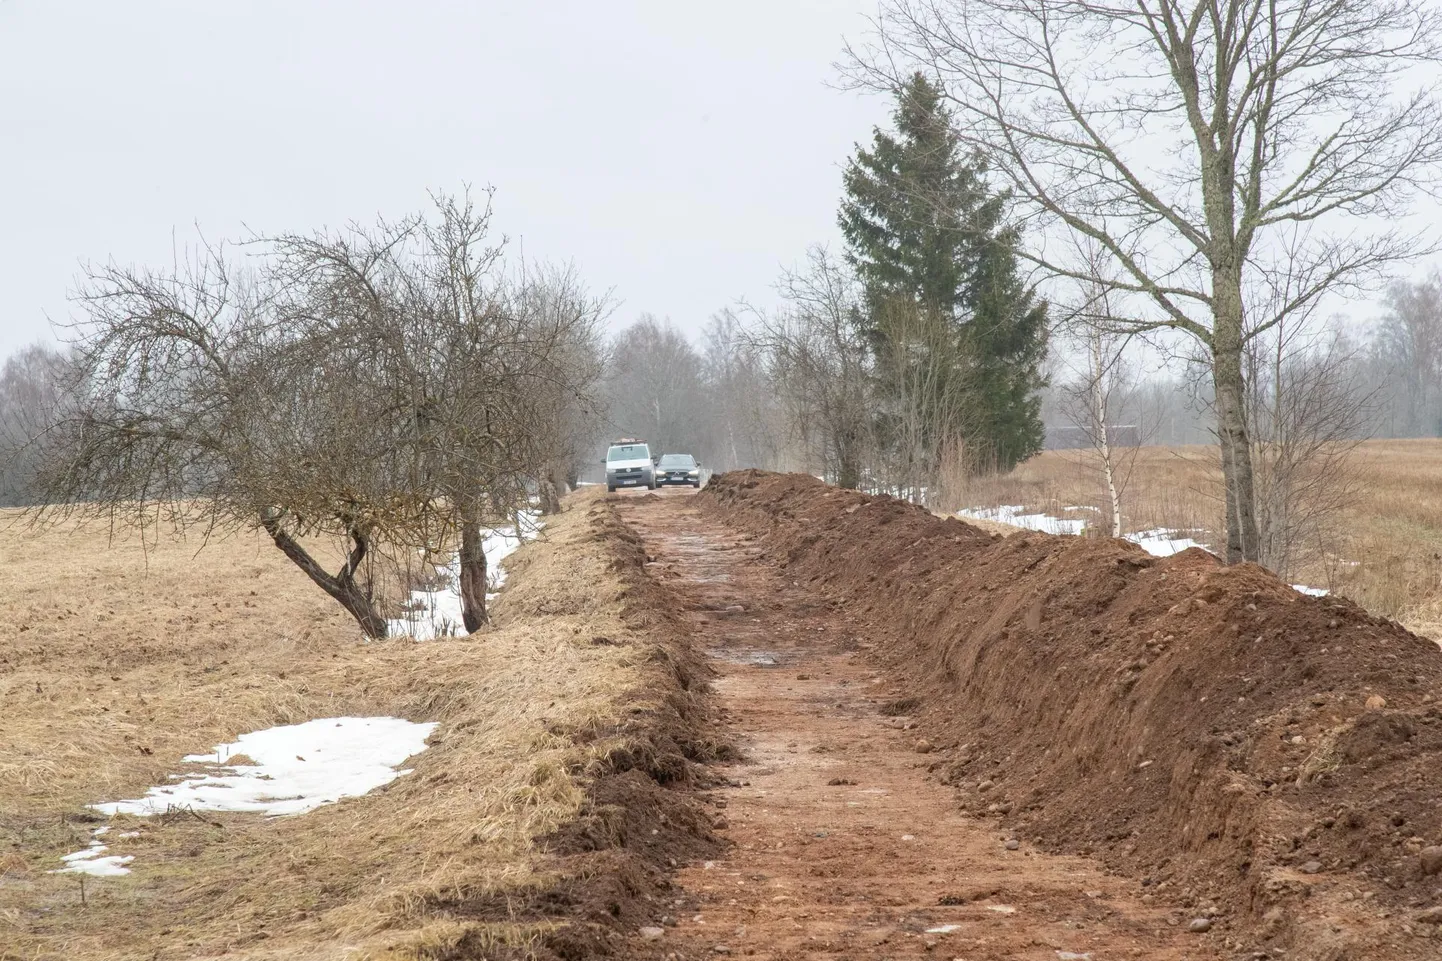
top-left (0, 0), bottom-right (888, 356)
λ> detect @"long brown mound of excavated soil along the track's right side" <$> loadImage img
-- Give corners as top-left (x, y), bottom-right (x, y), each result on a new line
top-left (701, 472), bottom-right (1442, 958)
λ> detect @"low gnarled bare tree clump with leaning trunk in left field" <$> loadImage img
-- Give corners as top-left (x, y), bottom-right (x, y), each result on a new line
top-left (29, 190), bottom-right (598, 638)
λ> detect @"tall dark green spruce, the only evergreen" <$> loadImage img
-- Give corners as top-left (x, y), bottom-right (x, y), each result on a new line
top-left (839, 74), bottom-right (1045, 469)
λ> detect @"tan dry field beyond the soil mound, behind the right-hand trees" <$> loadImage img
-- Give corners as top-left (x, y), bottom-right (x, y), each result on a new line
top-left (955, 440), bottom-right (1442, 639)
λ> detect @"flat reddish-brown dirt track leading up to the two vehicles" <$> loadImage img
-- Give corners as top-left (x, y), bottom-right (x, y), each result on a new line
top-left (622, 492), bottom-right (1231, 961)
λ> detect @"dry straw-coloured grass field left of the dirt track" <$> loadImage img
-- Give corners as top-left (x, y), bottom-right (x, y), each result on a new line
top-left (0, 493), bottom-right (660, 961)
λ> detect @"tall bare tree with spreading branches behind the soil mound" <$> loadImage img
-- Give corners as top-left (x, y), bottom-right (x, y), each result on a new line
top-left (851, 0), bottom-right (1442, 561)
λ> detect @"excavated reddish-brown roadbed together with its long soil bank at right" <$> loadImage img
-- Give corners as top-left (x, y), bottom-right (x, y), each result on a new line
top-left (605, 472), bottom-right (1442, 961)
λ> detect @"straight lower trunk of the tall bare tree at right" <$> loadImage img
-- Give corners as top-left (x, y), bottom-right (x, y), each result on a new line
top-left (1211, 276), bottom-right (1259, 564)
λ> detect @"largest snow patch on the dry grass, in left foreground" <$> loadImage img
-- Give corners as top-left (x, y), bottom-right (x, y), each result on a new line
top-left (91, 717), bottom-right (435, 817)
